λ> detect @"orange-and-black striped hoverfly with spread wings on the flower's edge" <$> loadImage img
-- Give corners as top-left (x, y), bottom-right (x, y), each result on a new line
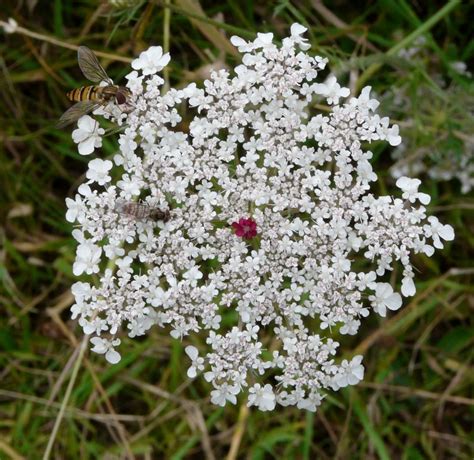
top-left (56, 46), bottom-right (132, 128)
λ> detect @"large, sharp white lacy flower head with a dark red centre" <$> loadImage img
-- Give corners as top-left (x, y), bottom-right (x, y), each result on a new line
top-left (66, 24), bottom-right (454, 411)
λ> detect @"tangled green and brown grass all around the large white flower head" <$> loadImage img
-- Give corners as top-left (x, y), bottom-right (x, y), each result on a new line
top-left (0, 0), bottom-right (474, 460)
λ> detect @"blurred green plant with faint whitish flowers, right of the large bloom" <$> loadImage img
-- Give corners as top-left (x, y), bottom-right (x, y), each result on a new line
top-left (382, 36), bottom-right (474, 194)
